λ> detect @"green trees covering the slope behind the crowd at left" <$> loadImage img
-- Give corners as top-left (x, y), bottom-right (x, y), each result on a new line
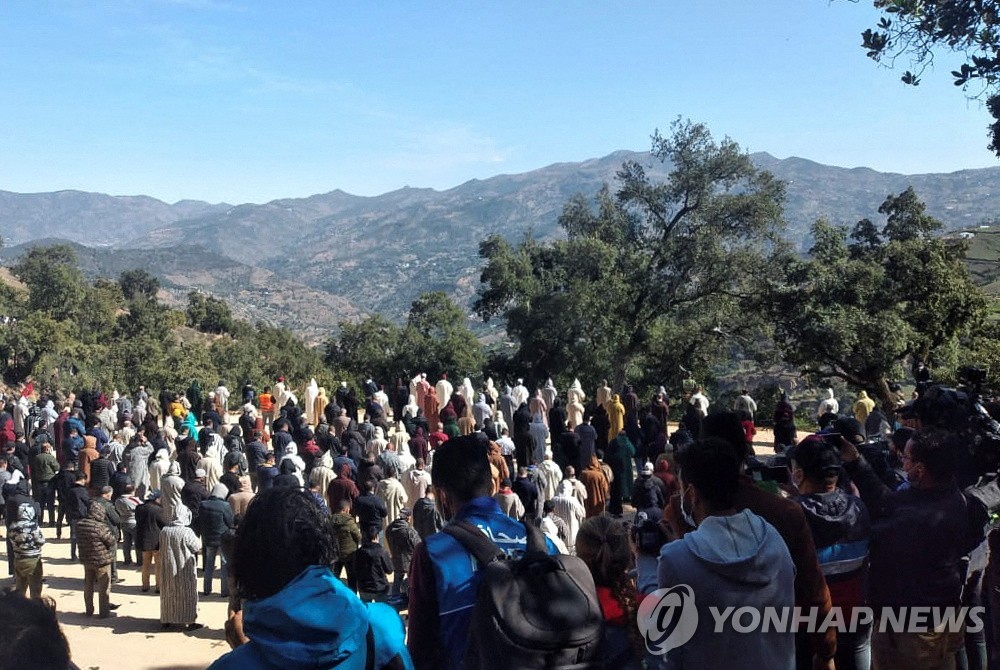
top-left (0, 245), bottom-right (332, 389)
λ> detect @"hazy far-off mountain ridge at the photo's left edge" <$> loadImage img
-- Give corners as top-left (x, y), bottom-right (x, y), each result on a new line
top-left (0, 191), bottom-right (229, 245)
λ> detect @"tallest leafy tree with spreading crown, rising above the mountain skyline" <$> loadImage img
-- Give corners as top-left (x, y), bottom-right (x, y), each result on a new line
top-left (475, 121), bottom-right (784, 388)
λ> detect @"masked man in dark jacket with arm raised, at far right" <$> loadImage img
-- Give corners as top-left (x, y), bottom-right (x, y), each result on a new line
top-left (840, 428), bottom-right (982, 668)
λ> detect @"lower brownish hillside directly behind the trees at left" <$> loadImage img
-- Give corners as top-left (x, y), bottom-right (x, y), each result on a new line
top-left (0, 239), bottom-right (359, 343)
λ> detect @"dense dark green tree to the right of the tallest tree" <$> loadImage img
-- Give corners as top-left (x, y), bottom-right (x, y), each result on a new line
top-left (766, 188), bottom-right (986, 403)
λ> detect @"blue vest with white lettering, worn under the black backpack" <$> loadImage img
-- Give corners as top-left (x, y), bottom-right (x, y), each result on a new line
top-left (424, 496), bottom-right (556, 670)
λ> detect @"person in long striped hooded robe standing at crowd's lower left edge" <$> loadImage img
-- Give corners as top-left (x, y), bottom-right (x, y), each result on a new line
top-left (160, 504), bottom-right (202, 630)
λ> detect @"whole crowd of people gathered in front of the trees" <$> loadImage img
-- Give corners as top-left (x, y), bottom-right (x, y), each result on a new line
top-left (0, 374), bottom-right (991, 670)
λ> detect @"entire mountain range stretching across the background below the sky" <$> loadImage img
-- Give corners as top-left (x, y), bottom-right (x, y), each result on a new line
top-left (0, 151), bottom-right (1000, 340)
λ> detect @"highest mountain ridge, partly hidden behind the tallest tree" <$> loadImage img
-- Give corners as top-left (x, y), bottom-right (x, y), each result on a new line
top-left (132, 151), bottom-right (1000, 318)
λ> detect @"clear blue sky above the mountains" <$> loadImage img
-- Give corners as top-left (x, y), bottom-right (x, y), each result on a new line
top-left (0, 0), bottom-right (997, 203)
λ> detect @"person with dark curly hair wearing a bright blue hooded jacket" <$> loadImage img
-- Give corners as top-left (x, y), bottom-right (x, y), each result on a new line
top-left (210, 488), bottom-right (413, 670)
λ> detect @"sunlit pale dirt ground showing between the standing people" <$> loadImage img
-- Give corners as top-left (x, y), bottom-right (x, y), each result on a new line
top-left (13, 429), bottom-right (788, 670)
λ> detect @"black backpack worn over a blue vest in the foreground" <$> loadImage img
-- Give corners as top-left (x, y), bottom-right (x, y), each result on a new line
top-left (442, 521), bottom-right (604, 670)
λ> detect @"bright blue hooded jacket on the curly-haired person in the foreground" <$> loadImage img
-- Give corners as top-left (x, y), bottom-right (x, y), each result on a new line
top-left (209, 565), bottom-right (413, 670)
